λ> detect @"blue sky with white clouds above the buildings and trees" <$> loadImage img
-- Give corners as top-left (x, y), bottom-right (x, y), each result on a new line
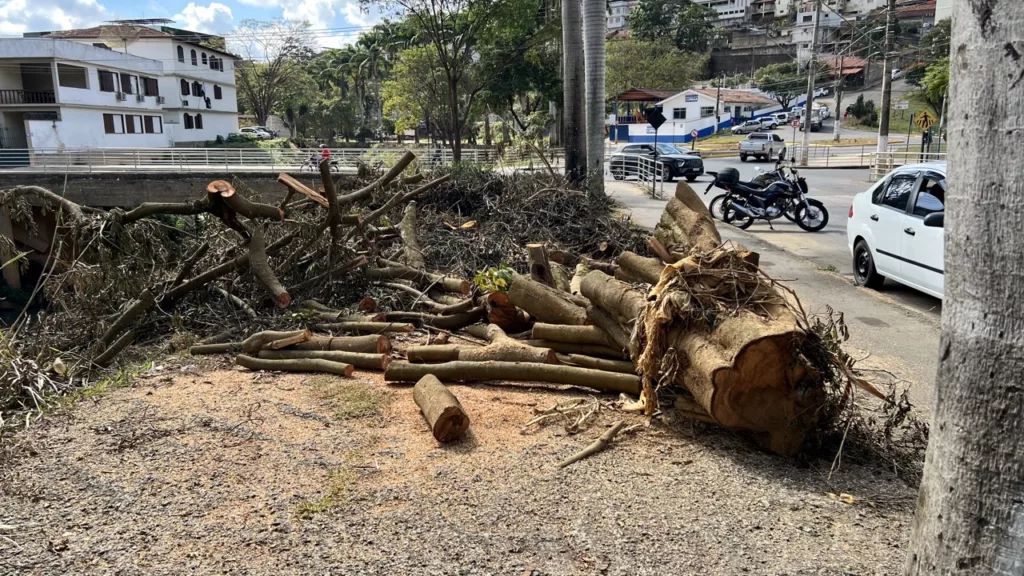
top-left (0, 0), bottom-right (380, 47)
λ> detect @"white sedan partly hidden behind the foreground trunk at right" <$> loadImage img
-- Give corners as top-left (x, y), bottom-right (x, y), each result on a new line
top-left (846, 162), bottom-right (946, 298)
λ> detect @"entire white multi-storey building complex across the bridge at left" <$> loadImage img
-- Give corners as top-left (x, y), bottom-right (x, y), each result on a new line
top-left (0, 27), bottom-right (238, 150)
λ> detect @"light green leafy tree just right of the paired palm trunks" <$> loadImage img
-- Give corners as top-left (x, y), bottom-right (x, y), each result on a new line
top-left (605, 38), bottom-right (708, 97)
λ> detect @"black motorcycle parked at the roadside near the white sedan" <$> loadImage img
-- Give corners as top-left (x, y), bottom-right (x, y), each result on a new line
top-left (705, 149), bottom-right (828, 232)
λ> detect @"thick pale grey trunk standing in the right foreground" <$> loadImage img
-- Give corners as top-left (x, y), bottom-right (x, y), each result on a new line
top-left (905, 0), bottom-right (1024, 576)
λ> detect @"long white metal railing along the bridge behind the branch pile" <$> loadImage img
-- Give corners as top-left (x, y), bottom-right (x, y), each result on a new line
top-left (0, 148), bottom-right (564, 173)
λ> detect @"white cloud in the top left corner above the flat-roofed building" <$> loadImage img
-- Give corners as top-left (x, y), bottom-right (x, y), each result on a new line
top-left (0, 0), bottom-right (112, 36)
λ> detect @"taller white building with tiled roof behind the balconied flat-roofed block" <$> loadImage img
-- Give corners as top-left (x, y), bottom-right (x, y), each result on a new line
top-left (47, 25), bottom-right (239, 146)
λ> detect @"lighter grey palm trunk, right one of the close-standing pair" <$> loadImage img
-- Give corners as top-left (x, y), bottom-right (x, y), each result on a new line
top-left (583, 0), bottom-right (608, 196)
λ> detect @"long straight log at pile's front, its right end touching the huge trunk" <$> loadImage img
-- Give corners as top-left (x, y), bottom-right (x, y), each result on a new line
top-left (384, 362), bottom-right (640, 395)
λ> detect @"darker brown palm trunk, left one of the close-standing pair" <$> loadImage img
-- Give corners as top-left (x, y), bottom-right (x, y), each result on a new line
top-left (562, 0), bottom-right (587, 182)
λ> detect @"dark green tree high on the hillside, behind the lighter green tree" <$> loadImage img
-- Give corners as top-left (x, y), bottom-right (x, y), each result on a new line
top-left (629, 0), bottom-right (718, 52)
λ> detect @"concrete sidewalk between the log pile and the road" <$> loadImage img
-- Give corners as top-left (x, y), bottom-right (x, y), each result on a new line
top-left (604, 181), bottom-right (939, 412)
